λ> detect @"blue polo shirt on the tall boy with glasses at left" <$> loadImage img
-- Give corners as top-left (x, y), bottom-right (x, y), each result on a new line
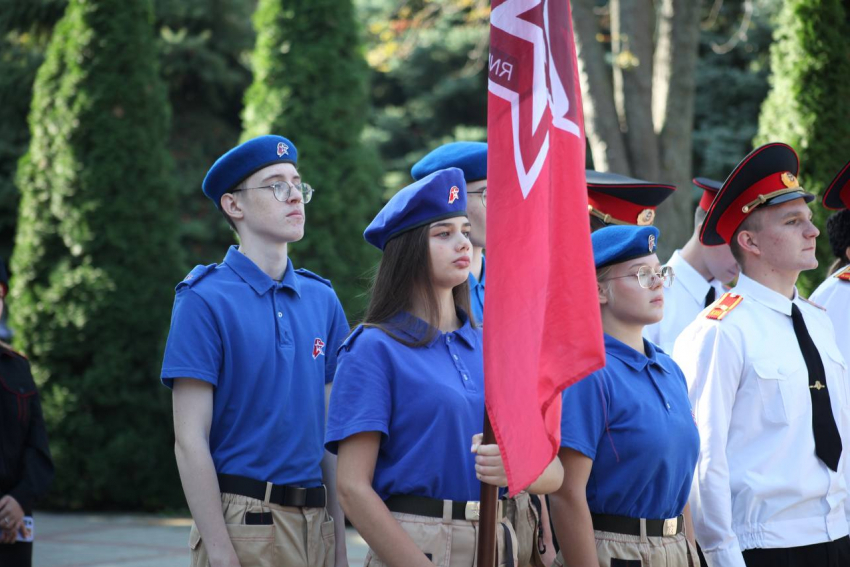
top-left (161, 246), bottom-right (348, 487)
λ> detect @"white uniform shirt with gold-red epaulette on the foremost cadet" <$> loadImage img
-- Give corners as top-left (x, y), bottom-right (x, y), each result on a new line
top-left (673, 275), bottom-right (850, 567)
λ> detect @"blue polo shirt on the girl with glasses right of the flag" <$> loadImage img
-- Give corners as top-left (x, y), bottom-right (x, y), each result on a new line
top-left (561, 334), bottom-right (699, 519)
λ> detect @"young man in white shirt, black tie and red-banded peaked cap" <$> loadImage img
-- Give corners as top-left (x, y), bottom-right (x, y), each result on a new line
top-left (673, 143), bottom-right (850, 567)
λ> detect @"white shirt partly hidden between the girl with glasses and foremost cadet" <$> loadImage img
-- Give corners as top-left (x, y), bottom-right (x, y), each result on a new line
top-left (643, 250), bottom-right (726, 354)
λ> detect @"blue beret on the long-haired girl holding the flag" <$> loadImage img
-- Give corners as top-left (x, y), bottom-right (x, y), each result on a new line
top-left (363, 167), bottom-right (466, 250)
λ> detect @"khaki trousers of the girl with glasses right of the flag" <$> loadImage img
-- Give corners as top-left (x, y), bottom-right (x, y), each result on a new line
top-left (552, 531), bottom-right (700, 567)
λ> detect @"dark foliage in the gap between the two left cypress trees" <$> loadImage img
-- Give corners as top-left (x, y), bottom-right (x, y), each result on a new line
top-left (156, 0), bottom-right (256, 266)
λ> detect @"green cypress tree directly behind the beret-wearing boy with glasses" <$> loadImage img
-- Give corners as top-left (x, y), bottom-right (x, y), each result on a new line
top-left (243, 0), bottom-right (383, 316)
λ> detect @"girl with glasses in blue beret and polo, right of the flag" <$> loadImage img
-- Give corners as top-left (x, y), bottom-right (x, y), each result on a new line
top-left (551, 226), bottom-right (699, 567)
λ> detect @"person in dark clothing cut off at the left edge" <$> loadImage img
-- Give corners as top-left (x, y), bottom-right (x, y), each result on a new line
top-left (0, 260), bottom-right (53, 567)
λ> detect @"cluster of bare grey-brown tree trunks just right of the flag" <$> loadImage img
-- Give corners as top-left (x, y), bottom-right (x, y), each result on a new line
top-left (572, 0), bottom-right (702, 259)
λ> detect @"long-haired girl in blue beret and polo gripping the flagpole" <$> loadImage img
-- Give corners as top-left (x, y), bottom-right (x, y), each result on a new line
top-left (325, 168), bottom-right (563, 567)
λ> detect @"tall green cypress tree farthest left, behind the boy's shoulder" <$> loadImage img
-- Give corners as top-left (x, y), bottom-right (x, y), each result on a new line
top-left (10, 0), bottom-right (183, 508)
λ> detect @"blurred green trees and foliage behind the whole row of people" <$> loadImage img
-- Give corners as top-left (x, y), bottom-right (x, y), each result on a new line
top-left (0, 0), bottom-right (850, 510)
